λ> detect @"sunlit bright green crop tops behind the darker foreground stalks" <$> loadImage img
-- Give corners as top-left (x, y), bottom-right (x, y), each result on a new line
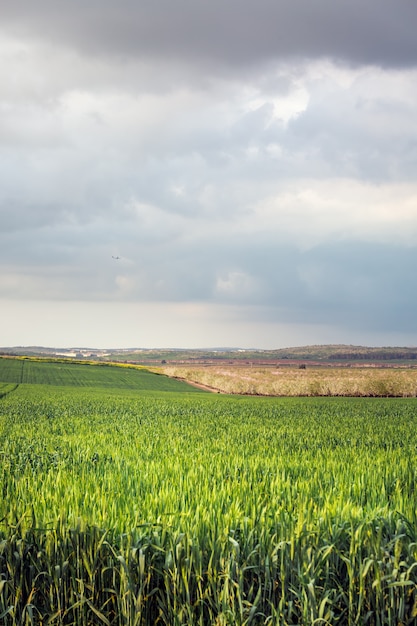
top-left (0, 385), bottom-right (417, 539)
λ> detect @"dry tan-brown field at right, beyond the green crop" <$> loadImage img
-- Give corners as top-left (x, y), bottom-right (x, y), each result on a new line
top-left (153, 365), bottom-right (417, 397)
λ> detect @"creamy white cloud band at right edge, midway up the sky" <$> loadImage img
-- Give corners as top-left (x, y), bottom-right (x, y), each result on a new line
top-left (245, 178), bottom-right (417, 249)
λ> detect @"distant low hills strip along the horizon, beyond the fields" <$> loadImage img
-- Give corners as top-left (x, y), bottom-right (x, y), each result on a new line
top-left (0, 344), bottom-right (417, 364)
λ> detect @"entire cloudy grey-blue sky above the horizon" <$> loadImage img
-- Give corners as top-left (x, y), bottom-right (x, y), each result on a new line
top-left (0, 0), bottom-right (417, 349)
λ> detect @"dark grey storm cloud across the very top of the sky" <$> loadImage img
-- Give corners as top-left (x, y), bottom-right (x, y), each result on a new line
top-left (2, 0), bottom-right (417, 71)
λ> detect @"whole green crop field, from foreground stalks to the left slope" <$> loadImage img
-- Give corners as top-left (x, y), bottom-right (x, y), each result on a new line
top-left (0, 359), bottom-right (417, 626)
